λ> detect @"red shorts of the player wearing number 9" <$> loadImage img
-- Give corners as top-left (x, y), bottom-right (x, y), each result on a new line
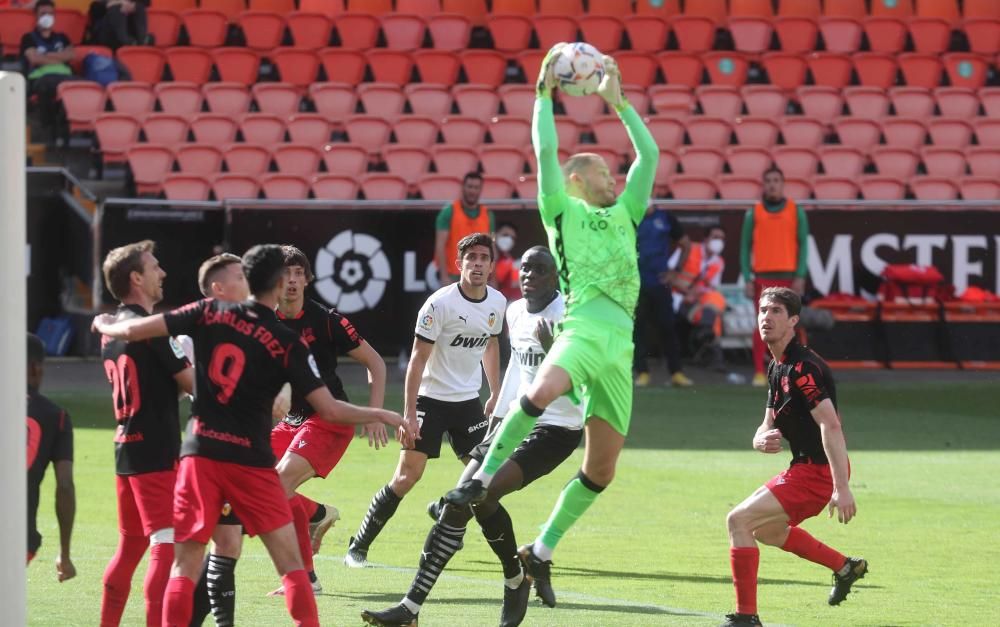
top-left (174, 455), bottom-right (292, 544)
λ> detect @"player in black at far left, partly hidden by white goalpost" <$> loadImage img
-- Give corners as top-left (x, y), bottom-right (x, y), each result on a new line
top-left (26, 333), bottom-right (76, 582)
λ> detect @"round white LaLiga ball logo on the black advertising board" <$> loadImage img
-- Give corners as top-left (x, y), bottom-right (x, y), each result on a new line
top-left (314, 231), bottom-right (392, 313)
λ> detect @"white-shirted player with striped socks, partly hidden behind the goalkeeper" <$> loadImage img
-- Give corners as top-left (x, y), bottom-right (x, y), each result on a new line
top-left (361, 246), bottom-right (583, 627)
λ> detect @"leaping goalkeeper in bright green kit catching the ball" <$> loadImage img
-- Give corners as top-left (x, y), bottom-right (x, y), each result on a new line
top-left (445, 44), bottom-right (659, 607)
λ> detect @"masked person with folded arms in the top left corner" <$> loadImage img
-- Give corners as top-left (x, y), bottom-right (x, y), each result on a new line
top-left (21, 0), bottom-right (77, 140)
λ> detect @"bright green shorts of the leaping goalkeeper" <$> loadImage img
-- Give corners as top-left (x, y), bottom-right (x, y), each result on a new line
top-left (544, 297), bottom-right (634, 435)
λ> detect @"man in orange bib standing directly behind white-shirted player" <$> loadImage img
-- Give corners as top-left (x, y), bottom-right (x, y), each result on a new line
top-left (434, 172), bottom-right (496, 287)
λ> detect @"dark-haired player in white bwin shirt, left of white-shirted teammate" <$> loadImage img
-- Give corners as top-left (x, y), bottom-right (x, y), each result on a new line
top-left (344, 233), bottom-right (507, 568)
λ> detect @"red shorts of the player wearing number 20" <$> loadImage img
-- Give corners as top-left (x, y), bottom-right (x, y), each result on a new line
top-left (116, 470), bottom-right (177, 537)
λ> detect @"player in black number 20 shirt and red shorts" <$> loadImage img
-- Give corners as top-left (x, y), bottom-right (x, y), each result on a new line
top-left (101, 240), bottom-right (194, 626)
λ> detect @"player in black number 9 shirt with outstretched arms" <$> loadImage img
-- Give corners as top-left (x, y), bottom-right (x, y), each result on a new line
top-left (94, 245), bottom-right (408, 627)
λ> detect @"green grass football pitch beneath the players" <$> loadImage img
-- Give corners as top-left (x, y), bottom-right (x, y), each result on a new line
top-left (27, 376), bottom-right (1000, 626)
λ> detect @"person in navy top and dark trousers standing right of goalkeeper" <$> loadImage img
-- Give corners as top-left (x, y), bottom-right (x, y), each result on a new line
top-left (633, 209), bottom-right (694, 387)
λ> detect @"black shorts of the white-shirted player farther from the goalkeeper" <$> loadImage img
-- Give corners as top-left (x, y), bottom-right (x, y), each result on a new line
top-left (412, 396), bottom-right (489, 459)
